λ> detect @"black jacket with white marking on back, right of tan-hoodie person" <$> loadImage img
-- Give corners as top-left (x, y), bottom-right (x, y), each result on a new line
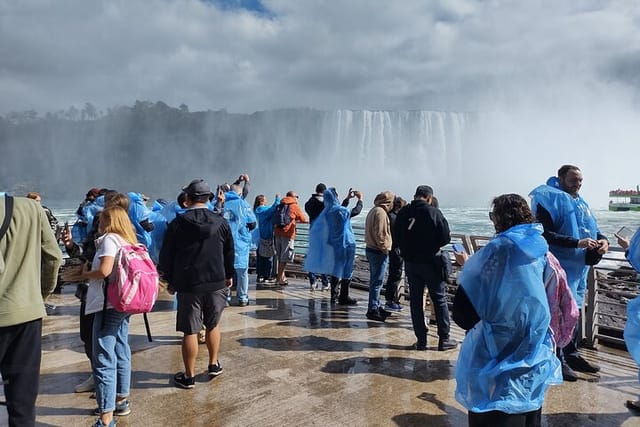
top-left (394, 199), bottom-right (451, 264)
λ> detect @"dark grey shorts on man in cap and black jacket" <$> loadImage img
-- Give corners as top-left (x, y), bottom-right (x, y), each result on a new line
top-left (176, 287), bottom-right (229, 335)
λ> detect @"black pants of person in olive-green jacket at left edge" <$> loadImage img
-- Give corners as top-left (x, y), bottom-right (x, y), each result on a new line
top-left (0, 319), bottom-right (42, 427)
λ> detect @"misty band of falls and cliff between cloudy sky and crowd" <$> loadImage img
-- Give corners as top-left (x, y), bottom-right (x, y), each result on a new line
top-left (0, 102), bottom-right (640, 208)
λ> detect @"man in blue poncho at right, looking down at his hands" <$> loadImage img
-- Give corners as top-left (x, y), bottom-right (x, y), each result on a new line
top-left (529, 165), bottom-right (609, 381)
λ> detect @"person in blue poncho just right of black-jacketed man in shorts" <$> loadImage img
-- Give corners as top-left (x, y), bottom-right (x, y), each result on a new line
top-left (222, 189), bottom-right (257, 307)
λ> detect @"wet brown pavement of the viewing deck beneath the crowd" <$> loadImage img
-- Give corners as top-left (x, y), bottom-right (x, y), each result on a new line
top-left (0, 279), bottom-right (640, 426)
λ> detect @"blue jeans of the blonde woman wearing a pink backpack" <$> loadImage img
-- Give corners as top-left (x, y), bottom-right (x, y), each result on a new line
top-left (93, 309), bottom-right (131, 413)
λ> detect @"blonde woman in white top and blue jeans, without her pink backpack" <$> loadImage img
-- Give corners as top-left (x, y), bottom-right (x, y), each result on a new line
top-left (80, 206), bottom-right (138, 427)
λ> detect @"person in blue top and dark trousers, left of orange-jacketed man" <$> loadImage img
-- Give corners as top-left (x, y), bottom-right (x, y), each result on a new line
top-left (253, 194), bottom-right (280, 288)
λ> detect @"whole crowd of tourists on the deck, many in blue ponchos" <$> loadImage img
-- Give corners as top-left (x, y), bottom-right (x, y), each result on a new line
top-left (0, 165), bottom-right (640, 427)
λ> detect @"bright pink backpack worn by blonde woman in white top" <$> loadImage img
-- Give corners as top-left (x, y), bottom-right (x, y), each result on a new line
top-left (105, 243), bottom-right (159, 314)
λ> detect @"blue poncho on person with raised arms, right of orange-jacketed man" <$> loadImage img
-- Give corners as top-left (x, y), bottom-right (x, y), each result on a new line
top-left (304, 188), bottom-right (356, 279)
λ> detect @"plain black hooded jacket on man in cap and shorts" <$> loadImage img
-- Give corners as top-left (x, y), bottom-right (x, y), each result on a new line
top-left (158, 208), bottom-right (235, 293)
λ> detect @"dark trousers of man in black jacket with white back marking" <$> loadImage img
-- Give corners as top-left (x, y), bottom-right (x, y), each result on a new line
top-left (404, 261), bottom-right (451, 345)
